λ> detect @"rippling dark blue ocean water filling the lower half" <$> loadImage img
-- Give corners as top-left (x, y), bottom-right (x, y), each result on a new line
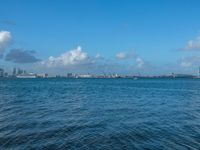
top-left (0, 79), bottom-right (200, 150)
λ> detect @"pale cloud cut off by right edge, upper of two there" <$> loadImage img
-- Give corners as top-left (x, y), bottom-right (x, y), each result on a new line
top-left (184, 36), bottom-right (200, 50)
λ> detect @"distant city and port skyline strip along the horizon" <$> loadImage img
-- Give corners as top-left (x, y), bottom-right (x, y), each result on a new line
top-left (0, 67), bottom-right (200, 80)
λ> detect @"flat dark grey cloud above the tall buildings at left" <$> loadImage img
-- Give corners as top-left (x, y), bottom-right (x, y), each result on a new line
top-left (5, 49), bottom-right (40, 63)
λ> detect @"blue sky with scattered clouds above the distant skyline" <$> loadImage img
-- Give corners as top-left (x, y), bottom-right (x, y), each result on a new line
top-left (0, 0), bottom-right (200, 75)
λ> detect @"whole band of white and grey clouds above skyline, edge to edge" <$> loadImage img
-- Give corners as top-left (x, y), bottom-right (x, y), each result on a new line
top-left (0, 30), bottom-right (200, 73)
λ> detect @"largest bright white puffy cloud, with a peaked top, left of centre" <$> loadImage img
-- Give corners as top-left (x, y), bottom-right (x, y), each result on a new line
top-left (42, 46), bottom-right (90, 67)
